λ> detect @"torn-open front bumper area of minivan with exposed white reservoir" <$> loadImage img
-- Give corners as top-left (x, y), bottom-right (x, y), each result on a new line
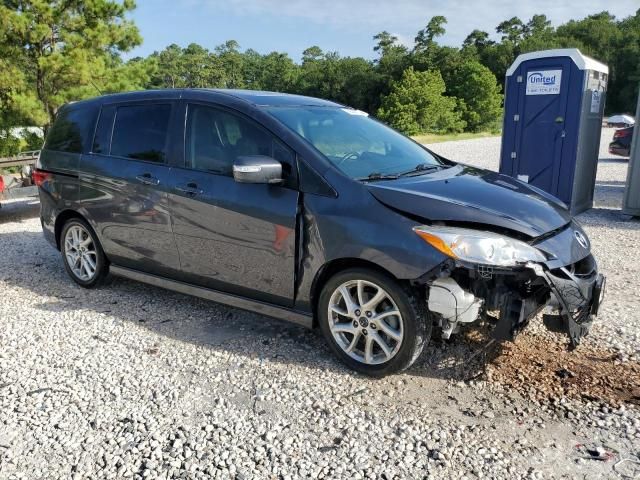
top-left (427, 255), bottom-right (605, 349)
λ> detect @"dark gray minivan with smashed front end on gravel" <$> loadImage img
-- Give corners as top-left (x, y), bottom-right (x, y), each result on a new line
top-left (34, 89), bottom-right (604, 376)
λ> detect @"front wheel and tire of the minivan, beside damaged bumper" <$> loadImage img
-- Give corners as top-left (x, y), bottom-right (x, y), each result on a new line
top-left (318, 268), bottom-right (432, 377)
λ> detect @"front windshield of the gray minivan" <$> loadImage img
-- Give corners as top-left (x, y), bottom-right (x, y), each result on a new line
top-left (268, 106), bottom-right (443, 179)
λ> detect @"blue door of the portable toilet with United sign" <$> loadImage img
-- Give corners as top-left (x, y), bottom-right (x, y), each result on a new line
top-left (515, 58), bottom-right (571, 195)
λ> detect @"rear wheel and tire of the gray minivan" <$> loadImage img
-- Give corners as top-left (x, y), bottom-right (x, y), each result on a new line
top-left (60, 218), bottom-right (109, 288)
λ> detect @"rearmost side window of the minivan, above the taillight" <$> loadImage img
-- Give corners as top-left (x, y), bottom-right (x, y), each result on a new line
top-left (44, 105), bottom-right (98, 153)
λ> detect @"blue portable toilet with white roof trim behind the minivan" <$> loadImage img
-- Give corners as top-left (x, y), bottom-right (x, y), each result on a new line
top-left (500, 48), bottom-right (609, 213)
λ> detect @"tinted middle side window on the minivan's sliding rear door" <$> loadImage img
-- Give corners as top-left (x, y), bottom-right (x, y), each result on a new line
top-left (111, 104), bottom-right (171, 163)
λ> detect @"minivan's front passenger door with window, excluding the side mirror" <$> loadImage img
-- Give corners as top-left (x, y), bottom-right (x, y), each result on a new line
top-left (169, 104), bottom-right (298, 306)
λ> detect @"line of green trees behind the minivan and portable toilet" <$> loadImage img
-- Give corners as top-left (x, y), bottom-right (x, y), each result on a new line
top-left (0, 0), bottom-right (640, 156)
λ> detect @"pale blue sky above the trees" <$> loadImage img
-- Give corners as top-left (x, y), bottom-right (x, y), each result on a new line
top-left (127, 0), bottom-right (640, 61)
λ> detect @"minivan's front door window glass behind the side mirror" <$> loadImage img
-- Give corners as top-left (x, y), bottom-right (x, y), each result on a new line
top-left (185, 105), bottom-right (273, 175)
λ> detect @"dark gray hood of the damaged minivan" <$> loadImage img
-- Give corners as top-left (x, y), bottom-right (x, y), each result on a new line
top-left (367, 165), bottom-right (571, 237)
